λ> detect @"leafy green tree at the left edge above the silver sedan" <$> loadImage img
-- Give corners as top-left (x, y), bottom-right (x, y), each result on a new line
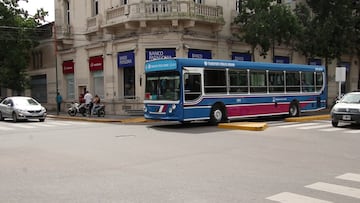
top-left (0, 0), bottom-right (47, 93)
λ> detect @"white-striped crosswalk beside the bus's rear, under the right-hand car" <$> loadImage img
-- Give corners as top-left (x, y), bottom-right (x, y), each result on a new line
top-left (270, 120), bottom-right (360, 134)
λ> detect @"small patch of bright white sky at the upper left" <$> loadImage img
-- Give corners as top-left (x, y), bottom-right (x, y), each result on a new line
top-left (19, 0), bottom-right (55, 22)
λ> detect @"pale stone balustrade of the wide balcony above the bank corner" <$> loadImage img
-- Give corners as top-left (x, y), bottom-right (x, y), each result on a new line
top-left (102, 0), bottom-right (224, 27)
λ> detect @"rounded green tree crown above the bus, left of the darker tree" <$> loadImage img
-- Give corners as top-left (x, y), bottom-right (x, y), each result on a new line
top-left (235, 0), bottom-right (299, 61)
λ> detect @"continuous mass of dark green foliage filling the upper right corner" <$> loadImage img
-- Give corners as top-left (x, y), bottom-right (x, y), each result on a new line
top-left (236, 0), bottom-right (360, 62)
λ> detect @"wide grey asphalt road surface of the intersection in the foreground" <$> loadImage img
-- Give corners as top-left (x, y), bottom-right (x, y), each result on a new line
top-left (0, 119), bottom-right (360, 203)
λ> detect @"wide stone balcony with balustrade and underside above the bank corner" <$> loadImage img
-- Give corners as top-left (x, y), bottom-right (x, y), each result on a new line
top-left (102, 0), bottom-right (225, 31)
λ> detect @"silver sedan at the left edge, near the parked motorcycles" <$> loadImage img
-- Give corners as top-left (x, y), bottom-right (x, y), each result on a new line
top-left (0, 96), bottom-right (47, 122)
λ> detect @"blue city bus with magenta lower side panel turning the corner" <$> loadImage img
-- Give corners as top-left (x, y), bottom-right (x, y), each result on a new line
top-left (144, 58), bottom-right (327, 124)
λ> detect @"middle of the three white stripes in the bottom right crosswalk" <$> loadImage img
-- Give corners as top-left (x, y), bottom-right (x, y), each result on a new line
top-left (305, 182), bottom-right (360, 199)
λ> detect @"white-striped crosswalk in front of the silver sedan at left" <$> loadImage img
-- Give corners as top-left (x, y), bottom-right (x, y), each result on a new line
top-left (0, 119), bottom-right (91, 132)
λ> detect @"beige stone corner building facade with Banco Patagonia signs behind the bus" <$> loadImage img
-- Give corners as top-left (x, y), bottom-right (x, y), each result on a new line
top-left (29, 0), bottom-right (360, 114)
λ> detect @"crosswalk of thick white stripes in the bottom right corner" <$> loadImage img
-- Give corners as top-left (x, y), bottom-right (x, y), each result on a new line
top-left (266, 173), bottom-right (360, 203)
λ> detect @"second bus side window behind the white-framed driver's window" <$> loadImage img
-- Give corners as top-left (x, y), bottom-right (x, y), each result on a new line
top-left (229, 70), bottom-right (249, 94)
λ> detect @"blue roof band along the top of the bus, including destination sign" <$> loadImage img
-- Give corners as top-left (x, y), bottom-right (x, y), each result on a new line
top-left (145, 58), bottom-right (325, 72)
